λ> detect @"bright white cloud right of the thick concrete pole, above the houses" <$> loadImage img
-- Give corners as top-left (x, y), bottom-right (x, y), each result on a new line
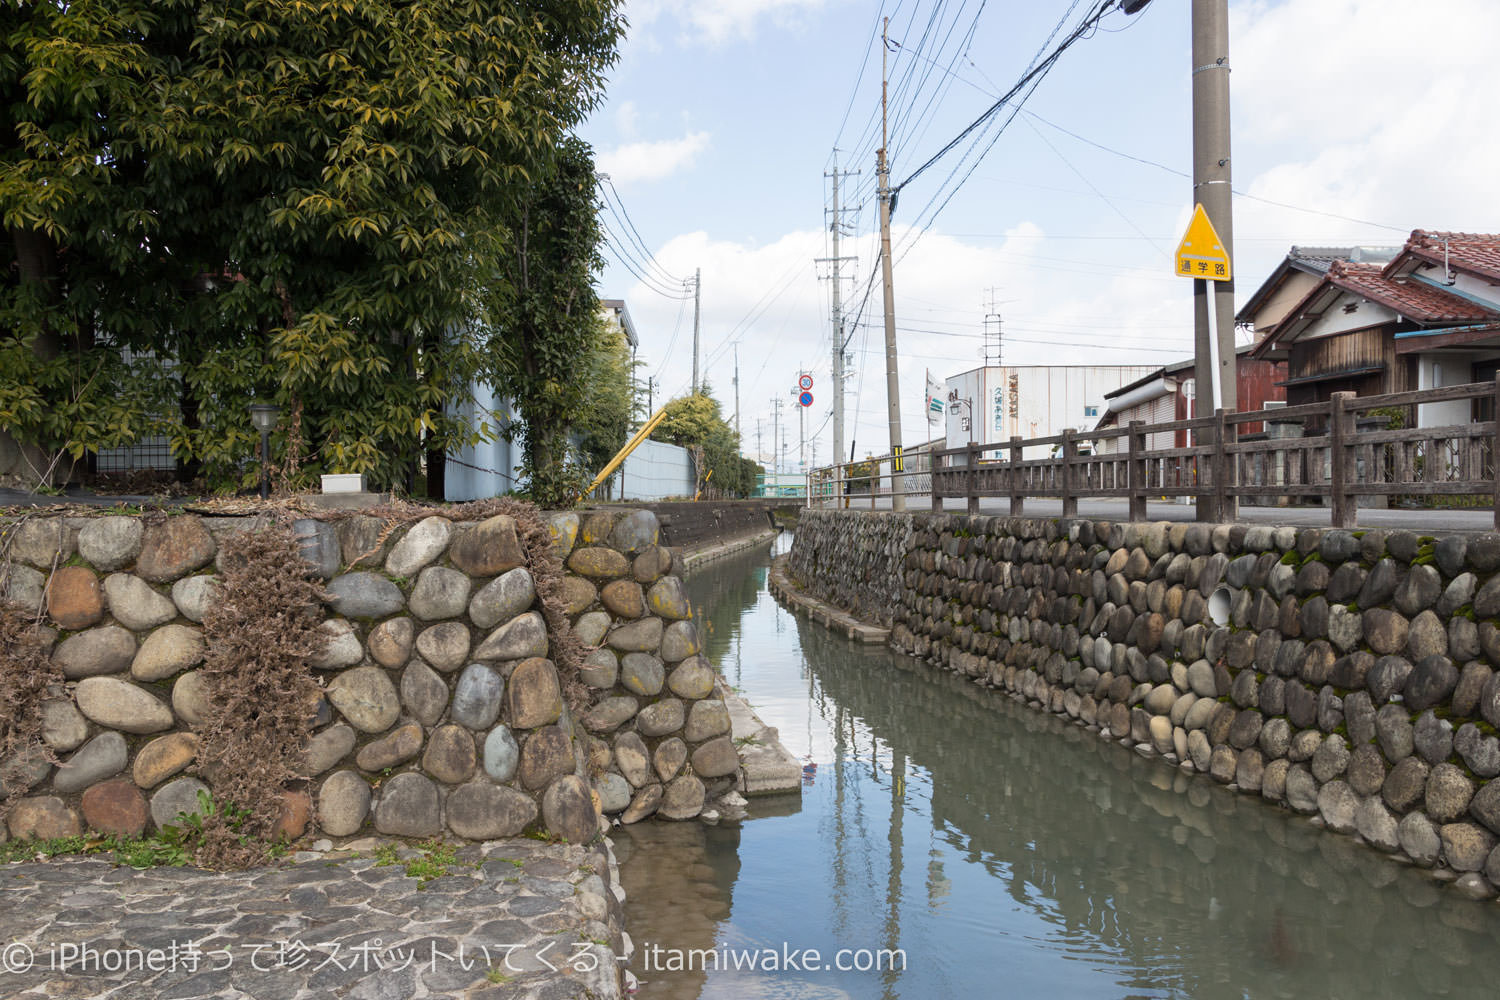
top-left (1230, 0), bottom-right (1500, 243)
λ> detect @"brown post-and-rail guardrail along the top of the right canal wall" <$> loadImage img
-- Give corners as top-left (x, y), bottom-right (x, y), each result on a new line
top-left (807, 375), bottom-right (1500, 529)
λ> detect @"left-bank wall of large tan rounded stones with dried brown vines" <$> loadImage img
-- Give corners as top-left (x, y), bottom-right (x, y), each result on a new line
top-left (0, 510), bottom-right (738, 843)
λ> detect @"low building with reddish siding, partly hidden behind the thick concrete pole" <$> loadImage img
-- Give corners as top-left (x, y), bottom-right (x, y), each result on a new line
top-left (1095, 343), bottom-right (1287, 454)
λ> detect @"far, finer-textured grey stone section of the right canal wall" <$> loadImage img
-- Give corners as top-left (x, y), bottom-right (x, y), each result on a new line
top-left (791, 510), bottom-right (914, 628)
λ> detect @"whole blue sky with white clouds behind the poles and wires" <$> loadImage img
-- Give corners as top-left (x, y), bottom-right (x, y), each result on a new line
top-left (581, 0), bottom-right (1500, 468)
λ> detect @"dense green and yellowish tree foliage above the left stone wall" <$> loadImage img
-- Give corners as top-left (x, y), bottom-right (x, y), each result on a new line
top-left (0, 0), bottom-right (623, 484)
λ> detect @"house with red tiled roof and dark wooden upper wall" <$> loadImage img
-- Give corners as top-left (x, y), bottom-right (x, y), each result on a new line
top-left (1242, 229), bottom-right (1500, 426)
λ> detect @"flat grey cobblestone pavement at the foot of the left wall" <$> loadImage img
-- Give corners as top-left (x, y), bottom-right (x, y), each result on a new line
top-left (0, 840), bottom-right (623, 1000)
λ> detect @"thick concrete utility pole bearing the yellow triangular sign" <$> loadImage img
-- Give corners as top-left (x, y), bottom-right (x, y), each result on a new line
top-left (1193, 0), bottom-right (1239, 520)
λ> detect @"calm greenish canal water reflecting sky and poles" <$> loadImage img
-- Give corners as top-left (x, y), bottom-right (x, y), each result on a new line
top-left (615, 541), bottom-right (1500, 1000)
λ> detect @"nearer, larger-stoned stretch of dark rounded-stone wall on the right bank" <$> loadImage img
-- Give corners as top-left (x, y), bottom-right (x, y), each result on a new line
top-left (794, 514), bottom-right (1500, 898)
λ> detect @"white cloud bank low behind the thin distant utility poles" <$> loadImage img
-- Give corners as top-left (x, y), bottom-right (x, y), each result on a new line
top-left (609, 223), bottom-right (1191, 462)
